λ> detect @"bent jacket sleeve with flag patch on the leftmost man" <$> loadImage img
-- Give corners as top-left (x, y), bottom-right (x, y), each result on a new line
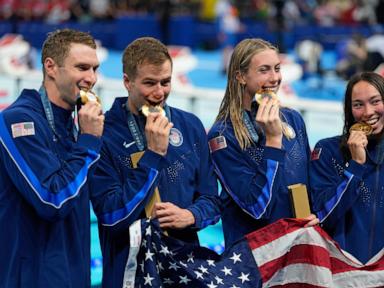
top-left (0, 111), bottom-right (101, 221)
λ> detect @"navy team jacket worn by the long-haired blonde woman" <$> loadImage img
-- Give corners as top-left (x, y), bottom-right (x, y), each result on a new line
top-left (208, 108), bottom-right (310, 247)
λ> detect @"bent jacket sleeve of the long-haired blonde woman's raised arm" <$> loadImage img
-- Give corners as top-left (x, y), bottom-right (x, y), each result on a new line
top-left (209, 130), bottom-right (285, 219)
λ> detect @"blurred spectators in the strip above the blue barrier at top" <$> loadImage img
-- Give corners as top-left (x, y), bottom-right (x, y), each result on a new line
top-left (0, 0), bottom-right (384, 26)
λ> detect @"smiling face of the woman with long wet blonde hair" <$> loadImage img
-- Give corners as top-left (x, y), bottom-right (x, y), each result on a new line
top-left (239, 49), bottom-right (281, 108)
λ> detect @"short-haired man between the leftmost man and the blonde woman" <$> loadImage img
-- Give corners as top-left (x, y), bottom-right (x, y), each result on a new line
top-left (91, 37), bottom-right (220, 287)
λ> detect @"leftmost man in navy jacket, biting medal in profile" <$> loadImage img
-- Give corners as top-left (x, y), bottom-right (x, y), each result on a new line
top-left (0, 29), bottom-right (104, 288)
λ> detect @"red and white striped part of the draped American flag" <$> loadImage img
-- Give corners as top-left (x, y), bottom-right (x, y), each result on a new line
top-left (246, 219), bottom-right (384, 288)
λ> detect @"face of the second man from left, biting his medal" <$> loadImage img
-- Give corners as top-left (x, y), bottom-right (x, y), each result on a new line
top-left (124, 60), bottom-right (172, 114)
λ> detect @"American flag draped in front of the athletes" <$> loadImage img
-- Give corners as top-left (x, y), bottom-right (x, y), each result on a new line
top-left (123, 219), bottom-right (384, 288)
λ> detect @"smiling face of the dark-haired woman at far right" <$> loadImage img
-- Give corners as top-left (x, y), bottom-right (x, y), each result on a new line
top-left (351, 81), bottom-right (384, 134)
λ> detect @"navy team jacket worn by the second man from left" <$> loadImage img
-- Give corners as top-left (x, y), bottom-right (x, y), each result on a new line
top-left (91, 97), bottom-right (220, 287)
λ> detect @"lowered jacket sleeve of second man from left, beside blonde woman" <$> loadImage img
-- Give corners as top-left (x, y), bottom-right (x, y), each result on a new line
top-left (188, 124), bottom-right (220, 229)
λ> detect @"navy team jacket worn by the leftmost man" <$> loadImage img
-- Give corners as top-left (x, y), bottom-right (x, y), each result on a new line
top-left (0, 90), bottom-right (101, 288)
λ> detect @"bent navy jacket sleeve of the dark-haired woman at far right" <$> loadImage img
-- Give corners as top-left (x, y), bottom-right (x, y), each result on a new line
top-left (309, 141), bottom-right (365, 228)
